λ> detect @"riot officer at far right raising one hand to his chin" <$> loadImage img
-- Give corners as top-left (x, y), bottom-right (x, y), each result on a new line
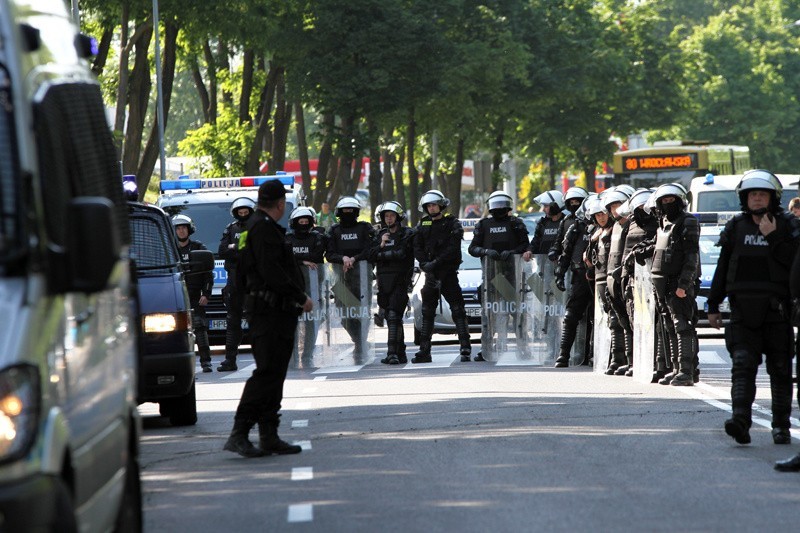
top-left (708, 170), bottom-right (800, 444)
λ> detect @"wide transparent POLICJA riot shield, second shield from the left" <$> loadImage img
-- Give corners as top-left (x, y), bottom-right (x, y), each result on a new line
top-left (315, 261), bottom-right (375, 367)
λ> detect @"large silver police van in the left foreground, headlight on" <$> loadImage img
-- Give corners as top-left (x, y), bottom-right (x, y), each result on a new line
top-left (0, 0), bottom-right (142, 532)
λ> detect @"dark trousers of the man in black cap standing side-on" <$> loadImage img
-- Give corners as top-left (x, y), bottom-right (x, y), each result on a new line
top-left (235, 309), bottom-right (297, 425)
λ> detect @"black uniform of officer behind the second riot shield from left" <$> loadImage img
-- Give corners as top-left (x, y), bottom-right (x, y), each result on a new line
top-left (325, 216), bottom-right (375, 355)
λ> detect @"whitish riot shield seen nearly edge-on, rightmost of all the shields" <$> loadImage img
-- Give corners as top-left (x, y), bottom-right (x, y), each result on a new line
top-left (633, 259), bottom-right (658, 383)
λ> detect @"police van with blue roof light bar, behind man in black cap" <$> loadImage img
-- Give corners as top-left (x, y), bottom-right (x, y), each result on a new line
top-left (156, 173), bottom-right (305, 345)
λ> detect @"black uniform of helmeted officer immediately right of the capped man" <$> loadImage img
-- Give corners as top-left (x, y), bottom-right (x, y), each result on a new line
top-left (286, 226), bottom-right (327, 367)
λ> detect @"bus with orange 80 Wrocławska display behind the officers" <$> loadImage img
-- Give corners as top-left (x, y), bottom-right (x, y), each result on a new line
top-left (614, 141), bottom-right (753, 190)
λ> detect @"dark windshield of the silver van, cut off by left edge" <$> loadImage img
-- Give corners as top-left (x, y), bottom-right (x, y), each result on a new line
top-left (0, 64), bottom-right (25, 266)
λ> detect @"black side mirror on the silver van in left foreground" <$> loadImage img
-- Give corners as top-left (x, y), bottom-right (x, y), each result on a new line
top-left (67, 196), bottom-right (121, 293)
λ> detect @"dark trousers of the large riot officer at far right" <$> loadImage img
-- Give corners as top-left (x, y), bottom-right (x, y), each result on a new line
top-left (725, 297), bottom-right (793, 428)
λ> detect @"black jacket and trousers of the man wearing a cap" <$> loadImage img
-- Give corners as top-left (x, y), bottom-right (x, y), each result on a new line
top-left (235, 210), bottom-right (307, 434)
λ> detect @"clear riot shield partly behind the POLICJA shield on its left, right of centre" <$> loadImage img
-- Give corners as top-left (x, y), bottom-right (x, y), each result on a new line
top-left (527, 254), bottom-right (567, 366)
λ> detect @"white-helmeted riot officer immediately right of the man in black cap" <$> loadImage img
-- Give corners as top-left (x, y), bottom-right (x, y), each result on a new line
top-left (286, 206), bottom-right (326, 366)
